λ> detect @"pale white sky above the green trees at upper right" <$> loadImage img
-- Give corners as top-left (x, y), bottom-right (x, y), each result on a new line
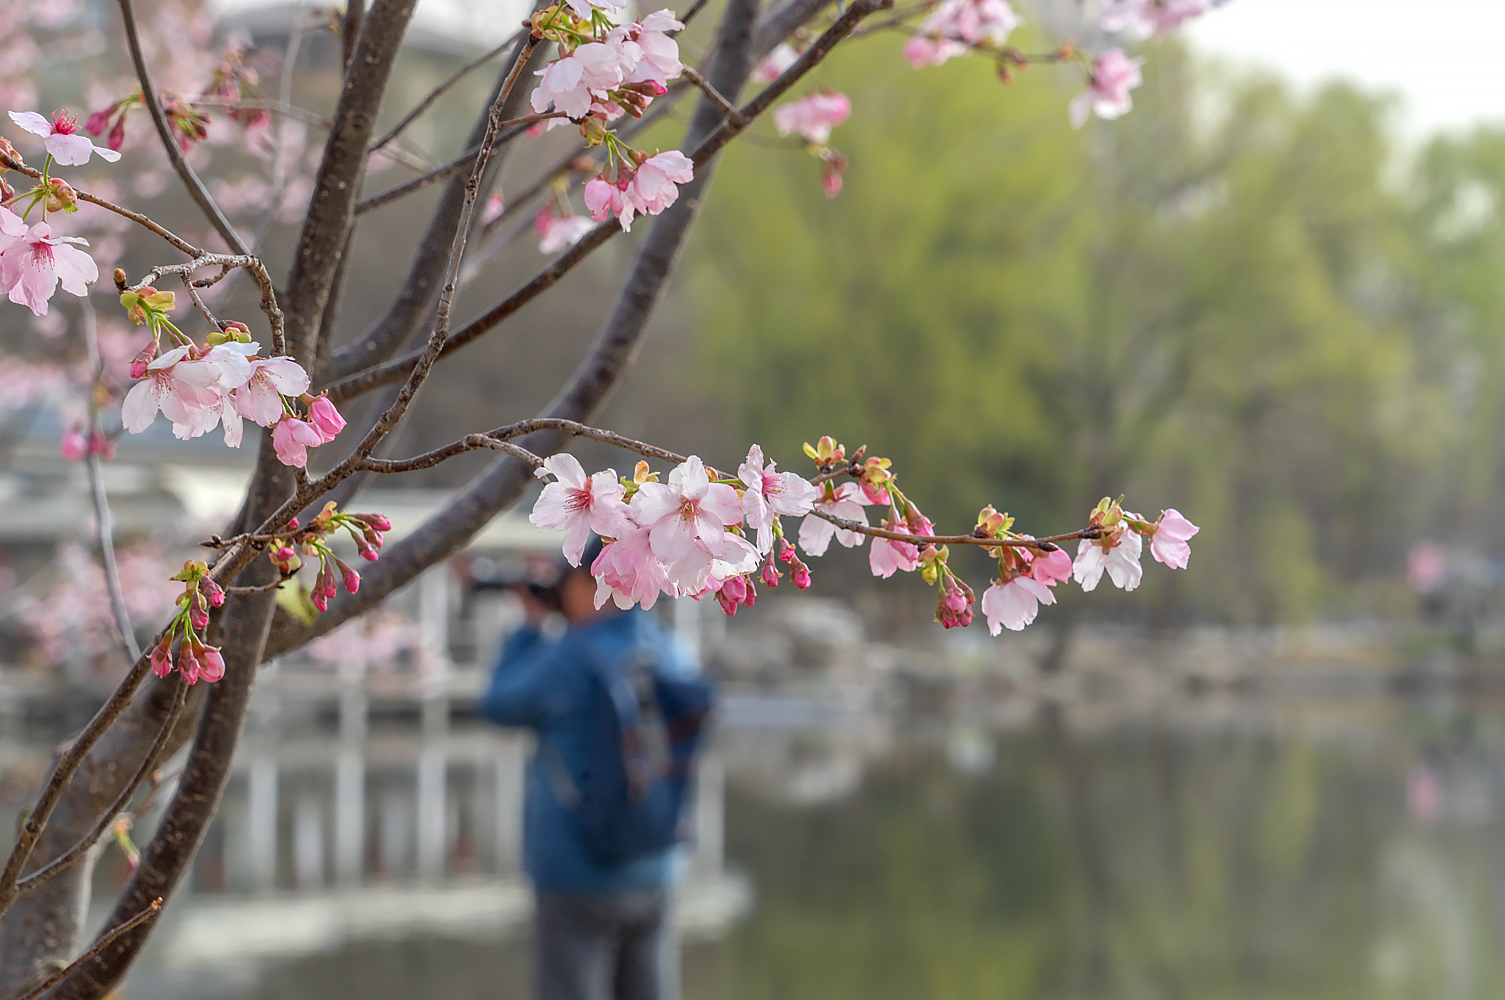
top-left (1189, 0), bottom-right (1505, 134)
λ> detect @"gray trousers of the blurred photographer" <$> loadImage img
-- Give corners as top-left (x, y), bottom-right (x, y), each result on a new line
top-left (533, 889), bottom-right (679, 1000)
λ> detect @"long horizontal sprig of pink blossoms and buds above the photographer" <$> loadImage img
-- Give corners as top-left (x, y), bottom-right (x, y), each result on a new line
top-left (530, 437), bottom-right (1199, 636)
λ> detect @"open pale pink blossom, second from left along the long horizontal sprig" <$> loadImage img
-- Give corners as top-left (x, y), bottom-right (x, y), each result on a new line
top-left (631, 455), bottom-right (756, 593)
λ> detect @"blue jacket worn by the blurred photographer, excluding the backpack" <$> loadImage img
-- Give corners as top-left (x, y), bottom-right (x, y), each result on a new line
top-left (480, 610), bottom-right (694, 892)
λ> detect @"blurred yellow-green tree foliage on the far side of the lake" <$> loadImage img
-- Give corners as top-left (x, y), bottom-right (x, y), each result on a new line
top-left (692, 41), bottom-right (1505, 622)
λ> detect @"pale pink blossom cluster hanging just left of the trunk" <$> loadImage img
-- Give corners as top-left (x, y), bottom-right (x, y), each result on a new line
top-left (120, 286), bottom-right (345, 468)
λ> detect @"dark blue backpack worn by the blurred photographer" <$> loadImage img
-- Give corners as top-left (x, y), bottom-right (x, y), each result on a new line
top-left (539, 645), bottom-right (715, 864)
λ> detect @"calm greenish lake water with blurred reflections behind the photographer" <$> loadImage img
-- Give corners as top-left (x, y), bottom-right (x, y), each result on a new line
top-left (88, 683), bottom-right (1505, 1000)
